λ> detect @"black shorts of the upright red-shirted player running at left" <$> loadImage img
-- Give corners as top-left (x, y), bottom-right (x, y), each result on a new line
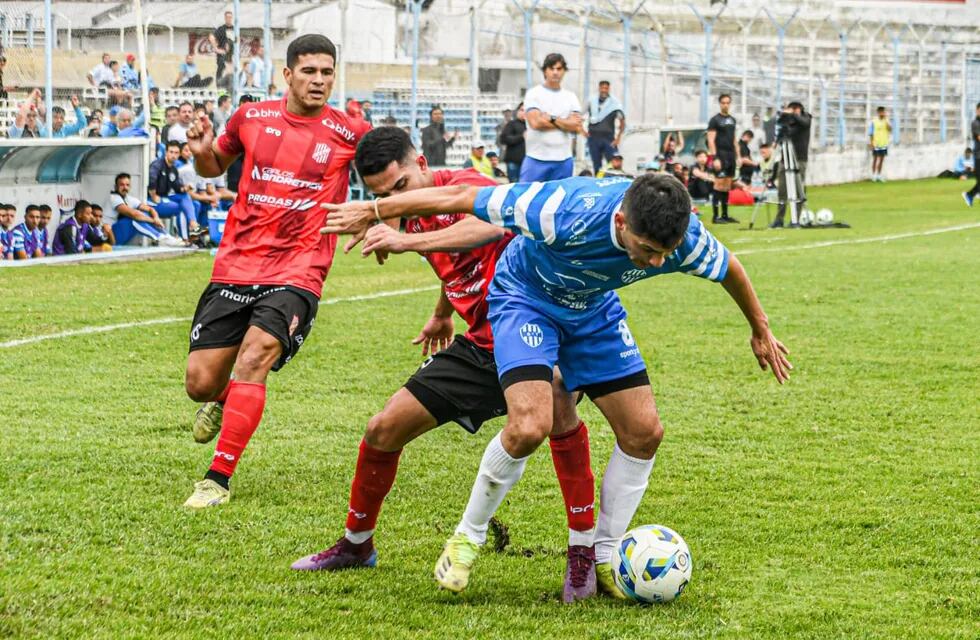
top-left (190, 282), bottom-right (320, 371)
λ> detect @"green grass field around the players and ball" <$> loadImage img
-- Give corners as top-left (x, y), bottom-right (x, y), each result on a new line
top-left (0, 180), bottom-right (980, 639)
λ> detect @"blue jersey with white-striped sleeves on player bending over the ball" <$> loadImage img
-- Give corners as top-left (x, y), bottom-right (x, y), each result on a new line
top-left (474, 177), bottom-right (729, 311)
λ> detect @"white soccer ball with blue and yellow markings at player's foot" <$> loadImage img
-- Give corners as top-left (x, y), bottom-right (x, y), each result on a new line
top-left (612, 524), bottom-right (691, 604)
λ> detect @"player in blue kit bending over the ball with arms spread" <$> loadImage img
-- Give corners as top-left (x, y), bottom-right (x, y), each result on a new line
top-left (323, 174), bottom-right (792, 598)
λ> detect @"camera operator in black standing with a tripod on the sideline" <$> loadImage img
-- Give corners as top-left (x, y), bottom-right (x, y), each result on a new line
top-left (771, 102), bottom-right (813, 228)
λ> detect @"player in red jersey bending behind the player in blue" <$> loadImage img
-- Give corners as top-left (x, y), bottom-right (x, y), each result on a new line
top-left (293, 127), bottom-right (595, 602)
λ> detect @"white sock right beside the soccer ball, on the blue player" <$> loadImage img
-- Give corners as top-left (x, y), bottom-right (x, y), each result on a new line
top-left (595, 444), bottom-right (657, 562)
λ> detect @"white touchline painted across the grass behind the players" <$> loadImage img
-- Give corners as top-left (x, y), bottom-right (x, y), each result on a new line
top-left (0, 222), bottom-right (980, 349)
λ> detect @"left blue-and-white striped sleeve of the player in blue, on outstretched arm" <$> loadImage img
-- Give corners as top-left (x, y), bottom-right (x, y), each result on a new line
top-left (473, 182), bottom-right (566, 245)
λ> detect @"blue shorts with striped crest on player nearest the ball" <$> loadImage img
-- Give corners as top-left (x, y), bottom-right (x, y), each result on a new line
top-left (487, 285), bottom-right (646, 391)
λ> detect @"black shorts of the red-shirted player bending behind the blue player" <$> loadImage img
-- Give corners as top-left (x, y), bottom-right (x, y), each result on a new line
top-left (405, 336), bottom-right (507, 433)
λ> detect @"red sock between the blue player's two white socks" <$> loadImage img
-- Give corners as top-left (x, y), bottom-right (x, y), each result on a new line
top-left (550, 421), bottom-right (595, 531)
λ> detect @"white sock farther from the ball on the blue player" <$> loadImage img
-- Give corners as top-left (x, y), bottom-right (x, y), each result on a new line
top-left (456, 433), bottom-right (530, 545)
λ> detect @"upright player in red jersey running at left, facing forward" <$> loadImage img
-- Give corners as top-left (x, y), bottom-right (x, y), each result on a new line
top-left (185, 34), bottom-right (370, 508)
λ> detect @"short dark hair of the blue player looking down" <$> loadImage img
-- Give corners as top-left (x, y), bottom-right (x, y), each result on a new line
top-left (623, 173), bottom-right (691, 247)
